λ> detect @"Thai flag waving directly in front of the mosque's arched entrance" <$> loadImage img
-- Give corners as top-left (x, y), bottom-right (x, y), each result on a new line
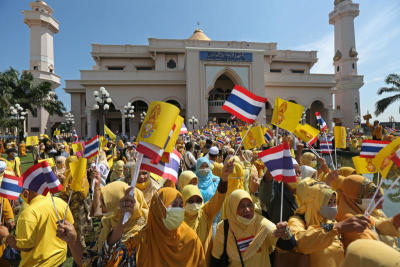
top-left (222, 85), bottom-right (267, 123)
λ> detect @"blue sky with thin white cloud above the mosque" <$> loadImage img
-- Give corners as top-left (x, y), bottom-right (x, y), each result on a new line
top-left (0, 0), bottom-right (400, 121)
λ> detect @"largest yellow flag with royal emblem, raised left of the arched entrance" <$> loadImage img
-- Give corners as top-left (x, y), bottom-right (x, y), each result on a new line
top-left (136, 101), bottom-right (179, 148)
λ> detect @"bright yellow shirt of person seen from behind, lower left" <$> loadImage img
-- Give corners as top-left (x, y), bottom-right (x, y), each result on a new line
top-left (15, 195), bottom-right (74, 267)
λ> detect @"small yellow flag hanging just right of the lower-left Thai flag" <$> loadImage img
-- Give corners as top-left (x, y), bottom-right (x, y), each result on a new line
top-left (70, 157), bottom-right (89, 197)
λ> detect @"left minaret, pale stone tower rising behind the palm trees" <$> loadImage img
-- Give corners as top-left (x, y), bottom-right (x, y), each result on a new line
top-left (23, 1), bottom-right (60, 134)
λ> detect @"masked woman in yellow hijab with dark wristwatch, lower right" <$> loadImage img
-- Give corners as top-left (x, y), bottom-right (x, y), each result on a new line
top-left (288, 178), bottom-right (344, 267)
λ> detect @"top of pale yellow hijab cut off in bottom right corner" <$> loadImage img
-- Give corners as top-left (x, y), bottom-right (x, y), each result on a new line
top-left (342, 239), bottom-right (400, 267)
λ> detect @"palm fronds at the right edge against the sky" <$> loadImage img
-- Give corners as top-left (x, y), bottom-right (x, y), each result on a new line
top-left (375, 73), bottom-right (400, 116)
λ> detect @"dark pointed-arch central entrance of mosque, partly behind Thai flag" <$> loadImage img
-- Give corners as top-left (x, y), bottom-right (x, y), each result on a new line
top-left (208, 74), bottom-right (235, 123)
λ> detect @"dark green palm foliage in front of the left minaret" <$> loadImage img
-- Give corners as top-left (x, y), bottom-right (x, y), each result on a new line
top-left (0, 67), bottom-right (66, 120)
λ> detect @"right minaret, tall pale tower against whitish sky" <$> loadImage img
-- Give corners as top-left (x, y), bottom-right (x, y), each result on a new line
top-left (329, 0), bottom-right (363, 127)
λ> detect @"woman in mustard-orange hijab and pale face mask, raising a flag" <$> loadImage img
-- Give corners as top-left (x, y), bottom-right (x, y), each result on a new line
top-left (104, 187), bottom-right (206, 267)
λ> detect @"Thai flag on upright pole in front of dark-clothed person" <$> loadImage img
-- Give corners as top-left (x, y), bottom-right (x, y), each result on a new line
top-left (258, 143), bottom-right (297, 183)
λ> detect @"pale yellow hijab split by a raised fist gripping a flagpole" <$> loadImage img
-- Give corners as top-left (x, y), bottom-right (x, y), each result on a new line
top-left (96, 181), bottom-right (149, 252)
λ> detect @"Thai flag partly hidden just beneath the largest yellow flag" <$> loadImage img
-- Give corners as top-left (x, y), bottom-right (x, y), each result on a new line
top-left (140, 149), bottom-right (181, 184)
